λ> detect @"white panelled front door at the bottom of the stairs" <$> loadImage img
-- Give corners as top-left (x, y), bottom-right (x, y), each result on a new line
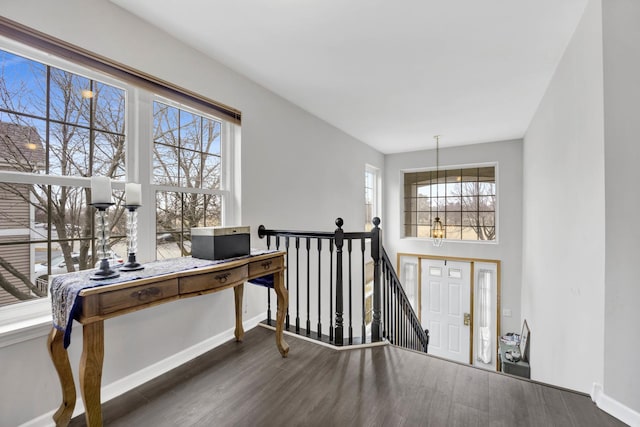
top-left (420, 259), bottom-right (471, 363)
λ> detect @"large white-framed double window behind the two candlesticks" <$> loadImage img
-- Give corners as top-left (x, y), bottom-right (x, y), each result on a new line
top-left (0, 32), bottom-right (240, 310)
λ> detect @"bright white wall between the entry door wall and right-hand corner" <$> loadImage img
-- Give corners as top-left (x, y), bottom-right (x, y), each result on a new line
top-left (522, 0), bottom-right (604, 392)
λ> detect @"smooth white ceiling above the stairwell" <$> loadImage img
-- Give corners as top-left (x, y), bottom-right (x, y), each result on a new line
top-left (111, 0), bottom-right (587, 153)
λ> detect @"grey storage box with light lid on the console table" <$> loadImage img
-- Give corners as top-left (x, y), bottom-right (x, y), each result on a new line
top-left (191, 227), bottom-right (251, 260)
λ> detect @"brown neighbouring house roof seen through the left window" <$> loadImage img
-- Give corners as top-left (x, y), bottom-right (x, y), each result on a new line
top-left (0, 122), bottom-right (45, 171)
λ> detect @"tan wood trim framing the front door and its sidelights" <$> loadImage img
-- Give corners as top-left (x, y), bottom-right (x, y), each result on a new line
top-left (396, 252), bottom-right (501, 369)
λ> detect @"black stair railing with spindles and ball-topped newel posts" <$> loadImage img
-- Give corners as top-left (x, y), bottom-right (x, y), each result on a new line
top-left (258, 217), bottom-right (429, 352)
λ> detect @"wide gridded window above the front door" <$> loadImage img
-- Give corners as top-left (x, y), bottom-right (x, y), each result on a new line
top-left (404, 166), bottom-right (496, 241)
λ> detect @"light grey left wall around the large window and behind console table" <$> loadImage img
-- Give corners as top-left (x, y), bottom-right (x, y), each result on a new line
top-left (0, 0), bottom-right (384, 425)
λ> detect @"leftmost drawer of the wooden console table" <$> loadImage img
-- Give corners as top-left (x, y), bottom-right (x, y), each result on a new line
top-left (97, 279), bottom-right (178, 315)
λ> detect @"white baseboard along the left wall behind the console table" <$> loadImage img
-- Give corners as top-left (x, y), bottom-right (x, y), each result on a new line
top-left (19, 313), bottom-right (265, 427)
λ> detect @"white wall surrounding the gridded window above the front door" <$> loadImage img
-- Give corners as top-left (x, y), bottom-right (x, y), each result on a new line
top-left (381, 140), bottom-right (522, 332)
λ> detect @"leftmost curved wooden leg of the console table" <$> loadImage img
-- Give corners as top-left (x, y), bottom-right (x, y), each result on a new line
top-left (47, 328), bottom-right (76, 427)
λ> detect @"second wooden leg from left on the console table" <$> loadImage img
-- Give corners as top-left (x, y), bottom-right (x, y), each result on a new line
top-left (80, 320), bottom-right (104, 427)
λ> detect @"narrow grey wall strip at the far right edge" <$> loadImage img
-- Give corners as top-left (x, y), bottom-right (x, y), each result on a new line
top-left (602, 0), bottom-right (640, 414)
